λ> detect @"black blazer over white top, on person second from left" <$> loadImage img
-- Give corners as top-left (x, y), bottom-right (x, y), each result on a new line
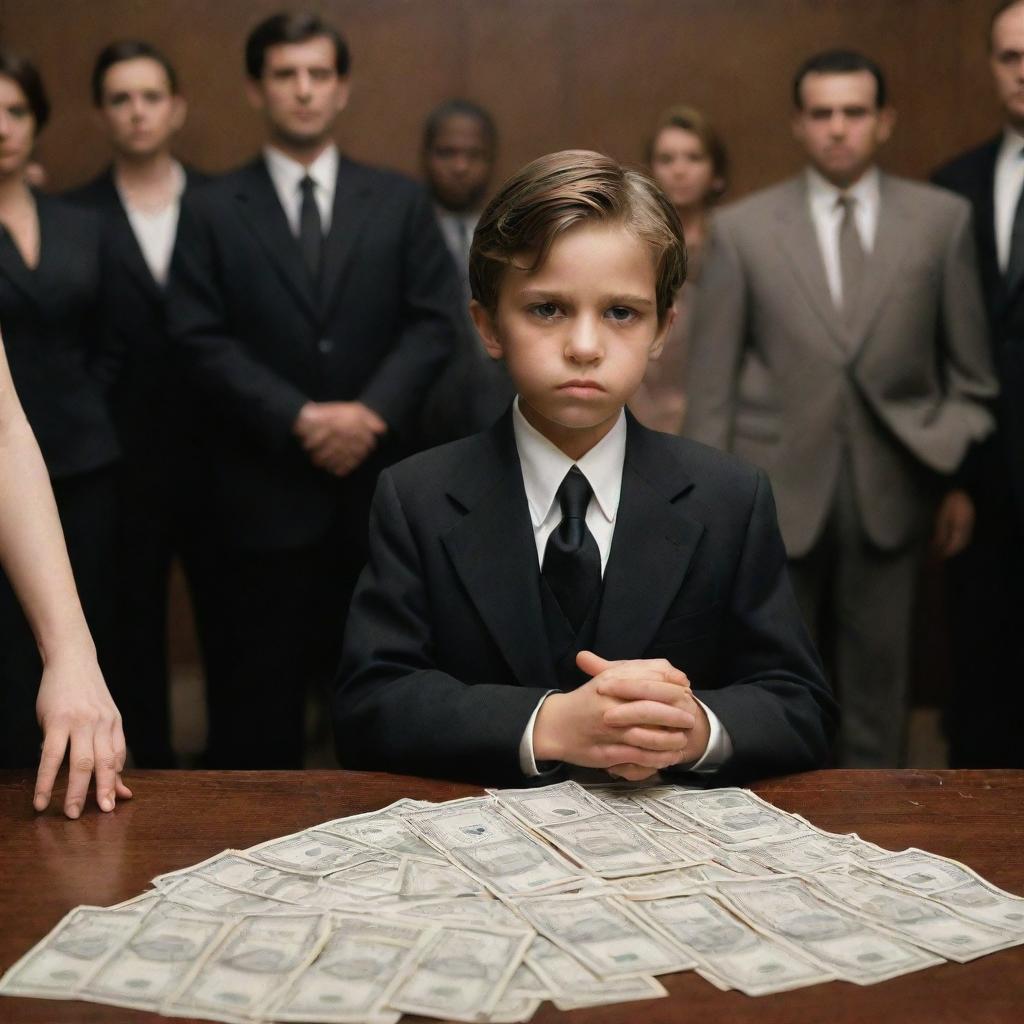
top-left (65, 168), bottom-right (208, 475)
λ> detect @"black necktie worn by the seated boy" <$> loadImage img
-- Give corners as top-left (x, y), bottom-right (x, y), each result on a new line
top-left (541, 466), bottom-right (601, 632)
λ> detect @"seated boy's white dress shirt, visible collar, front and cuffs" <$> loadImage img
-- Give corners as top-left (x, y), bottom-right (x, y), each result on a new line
top-left (512, 397), bottom-right (732, 775)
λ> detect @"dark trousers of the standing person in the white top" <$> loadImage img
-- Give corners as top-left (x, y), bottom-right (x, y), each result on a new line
top-left (110, 460), bottom-right (226, 768)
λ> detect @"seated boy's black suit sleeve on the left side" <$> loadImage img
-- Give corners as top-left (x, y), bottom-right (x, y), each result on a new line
top-left (334, 471), bottom-right (547, 782)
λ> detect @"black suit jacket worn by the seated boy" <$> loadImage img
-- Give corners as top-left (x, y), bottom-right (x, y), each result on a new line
top-left (334, 414), bottom-right (837, 782)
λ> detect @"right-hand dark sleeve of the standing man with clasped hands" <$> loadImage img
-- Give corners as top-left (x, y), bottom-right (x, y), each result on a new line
top-left (360, 188), bottom-right (459, 433)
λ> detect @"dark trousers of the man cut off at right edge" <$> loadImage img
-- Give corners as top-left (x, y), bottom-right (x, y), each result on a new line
top-left (946, 475), bottom-right (1024, 768)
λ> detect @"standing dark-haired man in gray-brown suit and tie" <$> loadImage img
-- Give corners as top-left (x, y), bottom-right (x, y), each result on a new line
top-left (686, 51), bottom-right (995, 767)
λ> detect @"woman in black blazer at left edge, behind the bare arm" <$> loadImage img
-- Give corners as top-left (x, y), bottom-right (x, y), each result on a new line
top-left (0, 50), bottom-right (126, 782)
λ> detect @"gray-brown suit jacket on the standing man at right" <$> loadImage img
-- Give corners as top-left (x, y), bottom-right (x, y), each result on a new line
top-left (685, 174), bottom-right (996, 557)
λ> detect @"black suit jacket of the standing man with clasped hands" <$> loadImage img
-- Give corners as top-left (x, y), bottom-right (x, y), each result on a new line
top-left (168, 157), bottom-right (457, 548)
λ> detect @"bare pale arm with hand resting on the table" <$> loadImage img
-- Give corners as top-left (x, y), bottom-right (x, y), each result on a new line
top-left (0, 342), bottom-right (131, 818)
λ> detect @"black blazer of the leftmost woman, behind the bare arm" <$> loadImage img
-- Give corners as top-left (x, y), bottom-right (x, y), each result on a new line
top-left (0, 193), bottom-right (119, 479)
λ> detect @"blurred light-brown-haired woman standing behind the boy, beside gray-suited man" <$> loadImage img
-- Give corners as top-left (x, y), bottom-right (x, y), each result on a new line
top-left (630, 106), bottom-right (728, 434)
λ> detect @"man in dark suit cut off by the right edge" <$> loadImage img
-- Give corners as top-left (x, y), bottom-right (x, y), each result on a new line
top-left (934, 0), bottom-right (1024, 768)
